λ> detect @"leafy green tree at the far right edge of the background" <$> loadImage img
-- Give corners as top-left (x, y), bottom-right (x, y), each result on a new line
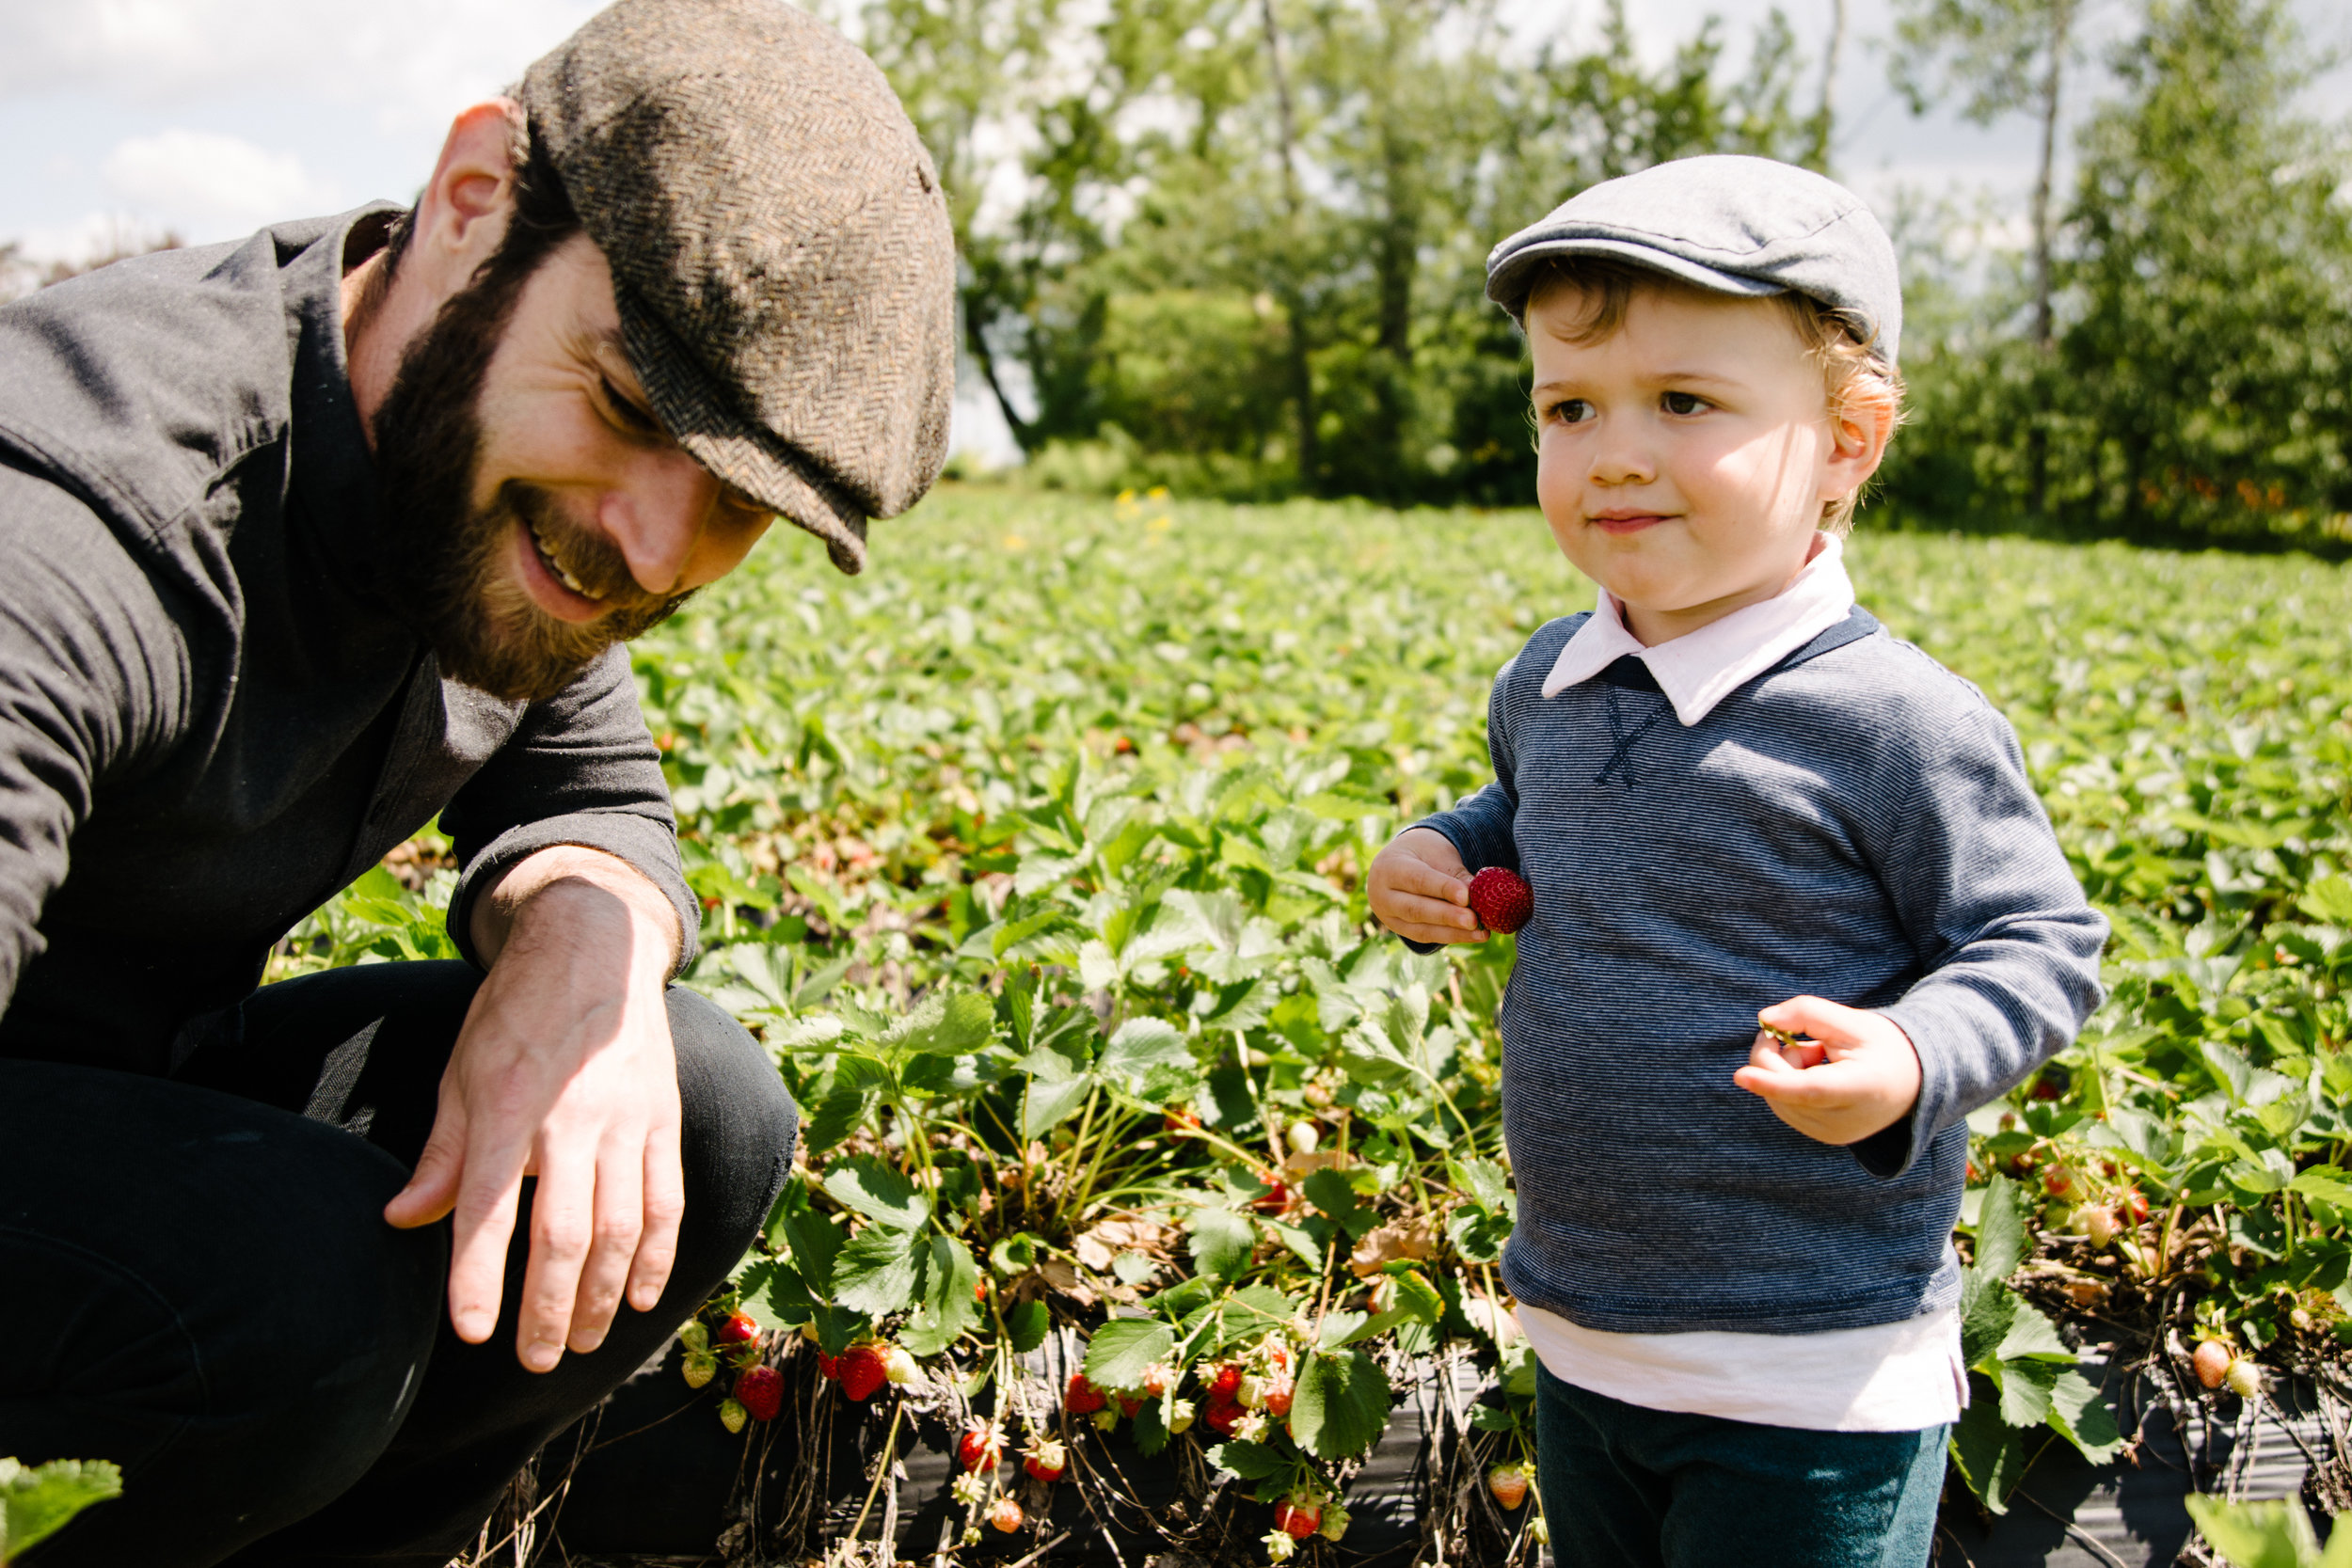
top-left (2054, 0), bottom-right (2352, 541)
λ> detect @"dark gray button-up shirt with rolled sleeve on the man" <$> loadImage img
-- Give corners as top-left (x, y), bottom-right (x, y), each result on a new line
top-left (0, 207), bottom-right (699, 1072)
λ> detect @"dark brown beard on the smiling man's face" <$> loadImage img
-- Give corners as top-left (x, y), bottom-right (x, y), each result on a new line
top-left (374, 226), bottom-right (687, 703)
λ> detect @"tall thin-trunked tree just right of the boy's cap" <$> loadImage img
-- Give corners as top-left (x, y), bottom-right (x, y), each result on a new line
top-left (1891, 0), bottom-right (2082, 515)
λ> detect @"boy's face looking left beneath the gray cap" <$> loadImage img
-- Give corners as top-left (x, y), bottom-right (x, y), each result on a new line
top-left (1527, 284), bottom-right (1884, 644)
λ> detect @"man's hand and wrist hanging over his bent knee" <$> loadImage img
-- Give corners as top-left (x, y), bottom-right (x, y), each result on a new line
top-left (384, 847), bottom-right (685, 1373)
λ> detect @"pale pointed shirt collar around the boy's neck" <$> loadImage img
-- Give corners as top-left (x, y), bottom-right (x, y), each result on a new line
top-left (1543, 533), bottom-right (1853, 726)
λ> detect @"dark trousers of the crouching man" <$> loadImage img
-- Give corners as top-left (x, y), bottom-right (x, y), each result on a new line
top-left (0, 964), bottom-right (798, 1568)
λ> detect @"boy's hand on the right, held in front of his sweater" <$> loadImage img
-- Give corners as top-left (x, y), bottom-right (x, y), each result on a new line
top-left (1731, 997), bottom-right (1919, 1145)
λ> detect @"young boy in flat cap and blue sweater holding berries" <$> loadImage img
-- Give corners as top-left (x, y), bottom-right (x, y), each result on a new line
top-left (1369, 157), bottom-right (2107, 1568)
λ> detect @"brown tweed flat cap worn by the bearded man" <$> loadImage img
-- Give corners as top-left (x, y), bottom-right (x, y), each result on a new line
top-left (522, 0), bottom-right (955, 571)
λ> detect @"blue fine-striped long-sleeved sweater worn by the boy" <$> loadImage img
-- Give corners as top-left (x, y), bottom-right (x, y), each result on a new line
top-left (1421, 609), bottom-right (2107, 1333)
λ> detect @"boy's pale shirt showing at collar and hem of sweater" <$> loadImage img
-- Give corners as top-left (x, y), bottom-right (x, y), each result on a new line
top-left (1519, 533), bottom-right (1969, 1432)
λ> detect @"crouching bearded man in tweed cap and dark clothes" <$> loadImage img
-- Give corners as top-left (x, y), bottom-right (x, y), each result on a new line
top-left (0, 0), bottom-right (953, 1568)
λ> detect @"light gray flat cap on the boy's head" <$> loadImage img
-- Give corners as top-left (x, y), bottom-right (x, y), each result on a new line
top-left (1486, 155), bottom-right (1903, 364)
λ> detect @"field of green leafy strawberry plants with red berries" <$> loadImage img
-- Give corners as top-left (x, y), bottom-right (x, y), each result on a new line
top-left (294, 489), bottom-right (2352, 1563)
